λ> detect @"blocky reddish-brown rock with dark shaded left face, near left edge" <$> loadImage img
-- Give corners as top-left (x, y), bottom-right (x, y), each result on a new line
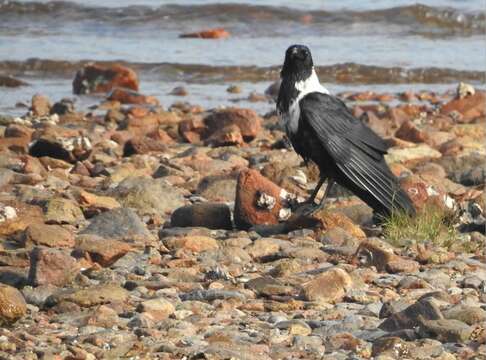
top-left (29, 247), bottom-right (79, 286)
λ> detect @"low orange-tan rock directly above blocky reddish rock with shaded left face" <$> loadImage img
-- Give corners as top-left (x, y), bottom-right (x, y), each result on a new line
top-left (22, 224), bottom-right (74, 249)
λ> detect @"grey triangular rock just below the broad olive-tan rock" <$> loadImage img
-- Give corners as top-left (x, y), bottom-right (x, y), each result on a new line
top-left (81, 208), bottom-right (153, 244)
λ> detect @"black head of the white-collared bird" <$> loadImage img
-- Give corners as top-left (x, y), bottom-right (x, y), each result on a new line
top-left (280, 45), bottom-right (314, 80)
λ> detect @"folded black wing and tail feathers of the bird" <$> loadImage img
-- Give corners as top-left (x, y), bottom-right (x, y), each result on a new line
top-left (300, 93), bottom-right (415, 214)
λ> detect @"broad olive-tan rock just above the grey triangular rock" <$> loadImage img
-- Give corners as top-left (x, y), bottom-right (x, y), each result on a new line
top-left (112, 177), bottom-right (185, 218)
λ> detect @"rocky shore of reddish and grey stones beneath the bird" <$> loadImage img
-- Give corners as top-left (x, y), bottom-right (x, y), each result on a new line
top-left (0, 65), bottom-right (486, 360)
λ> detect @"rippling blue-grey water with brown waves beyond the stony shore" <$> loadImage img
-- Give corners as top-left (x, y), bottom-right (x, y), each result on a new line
top-left (0, 0), bottom-right (486, 113)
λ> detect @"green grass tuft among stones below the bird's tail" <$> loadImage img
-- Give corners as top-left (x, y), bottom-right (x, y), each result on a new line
top-left (383, 206), bottom-right (460, 249)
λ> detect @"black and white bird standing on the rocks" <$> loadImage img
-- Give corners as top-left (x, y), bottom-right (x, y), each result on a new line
top-left (277, 45), bottom-right (415, 216)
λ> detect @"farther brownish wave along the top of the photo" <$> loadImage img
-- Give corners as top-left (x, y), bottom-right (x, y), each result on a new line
top-left (0, 0), bottom-right (486, 34)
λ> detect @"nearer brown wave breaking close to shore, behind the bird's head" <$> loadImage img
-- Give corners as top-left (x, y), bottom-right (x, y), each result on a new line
top-left (0, 59), bottom-right (486, 84)
